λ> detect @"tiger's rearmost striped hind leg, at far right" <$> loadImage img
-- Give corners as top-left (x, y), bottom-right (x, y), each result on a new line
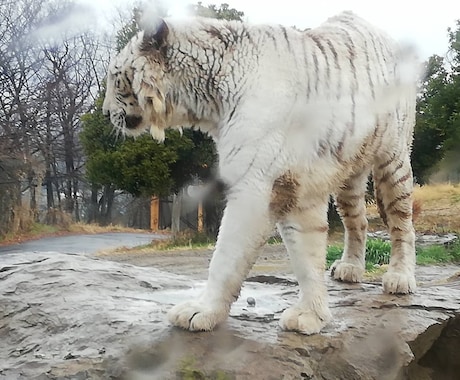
top-left (374, 149), bottom-right (416, 294)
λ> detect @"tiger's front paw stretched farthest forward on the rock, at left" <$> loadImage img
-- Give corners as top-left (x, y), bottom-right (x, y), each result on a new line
top-left (168, 301), bottom-right (229, 331)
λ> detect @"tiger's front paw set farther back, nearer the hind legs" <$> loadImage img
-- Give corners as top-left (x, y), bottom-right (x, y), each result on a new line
top-left (280, 306), bottom-right (331, 335)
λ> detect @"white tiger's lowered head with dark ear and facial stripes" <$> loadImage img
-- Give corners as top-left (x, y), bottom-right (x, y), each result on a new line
top-left (103, 20), bottom-right (174, 141)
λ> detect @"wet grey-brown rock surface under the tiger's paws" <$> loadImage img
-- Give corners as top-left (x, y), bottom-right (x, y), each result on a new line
top-left (0, 246), bottom-right (460, 380)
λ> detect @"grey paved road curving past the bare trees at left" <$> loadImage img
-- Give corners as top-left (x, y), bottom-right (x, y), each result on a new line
top-left (0, 232), bottom-right (166, 255)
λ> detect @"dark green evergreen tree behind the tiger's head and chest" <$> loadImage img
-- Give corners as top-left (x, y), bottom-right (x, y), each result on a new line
top-left (80, 3), bottom-right (243, 226)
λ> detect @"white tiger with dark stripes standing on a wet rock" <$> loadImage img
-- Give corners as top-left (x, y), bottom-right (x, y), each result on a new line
top-left (103, 12), bottom-right (416, 334)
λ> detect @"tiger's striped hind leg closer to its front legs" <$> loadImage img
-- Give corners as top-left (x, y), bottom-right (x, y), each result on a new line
top-left (331, 170), bottom-right (368, 282)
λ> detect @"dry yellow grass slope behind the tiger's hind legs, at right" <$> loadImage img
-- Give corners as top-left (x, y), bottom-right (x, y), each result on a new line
top-left (368, 183), bottom-right (460, 234)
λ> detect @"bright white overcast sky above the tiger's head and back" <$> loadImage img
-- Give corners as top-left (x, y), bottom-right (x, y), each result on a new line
top-left (80, 0), bottom-right (460, 59)
